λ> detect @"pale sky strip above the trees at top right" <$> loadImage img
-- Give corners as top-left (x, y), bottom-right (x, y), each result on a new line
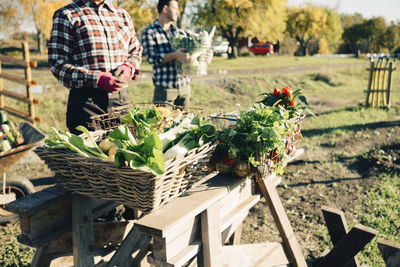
top-left (288, 0), bottom-right (400, 22)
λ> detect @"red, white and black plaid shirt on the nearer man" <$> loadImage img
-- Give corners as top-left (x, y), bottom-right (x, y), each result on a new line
top-left (48, 0), bottom-right (142, 89)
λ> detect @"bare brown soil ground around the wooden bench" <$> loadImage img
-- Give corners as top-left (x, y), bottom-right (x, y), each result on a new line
top-left (1, 62), bottom-right (400, 266)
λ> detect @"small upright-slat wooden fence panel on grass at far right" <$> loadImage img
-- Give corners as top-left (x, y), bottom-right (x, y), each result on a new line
top-left (366, 57), bottom-right (396, 108)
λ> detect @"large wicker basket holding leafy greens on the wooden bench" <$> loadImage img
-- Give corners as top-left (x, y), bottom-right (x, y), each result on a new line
top-left (35, 143), bottom-right (215, 212)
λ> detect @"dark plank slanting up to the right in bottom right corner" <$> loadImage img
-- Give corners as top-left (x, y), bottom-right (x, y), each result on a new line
top-left (317, 224), bottom-right (378, 267)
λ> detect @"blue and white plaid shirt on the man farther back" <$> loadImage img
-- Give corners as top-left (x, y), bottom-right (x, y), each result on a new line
top-left (141, 19), bottom-right (190, 88)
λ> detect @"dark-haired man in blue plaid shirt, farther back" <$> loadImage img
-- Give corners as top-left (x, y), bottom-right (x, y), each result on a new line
top-left (141, 0), bottom-right (190, 106)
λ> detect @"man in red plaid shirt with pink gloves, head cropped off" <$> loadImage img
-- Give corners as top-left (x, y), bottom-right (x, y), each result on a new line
top-left (48, 0), bottom-right (142, 133)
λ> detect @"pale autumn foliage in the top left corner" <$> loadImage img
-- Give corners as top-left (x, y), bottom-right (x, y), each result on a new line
top-left (0, 0), bottom-right (21, 39)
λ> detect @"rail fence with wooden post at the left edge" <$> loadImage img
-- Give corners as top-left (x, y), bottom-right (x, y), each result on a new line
top-left (0, 42), bottom-right (40, 124)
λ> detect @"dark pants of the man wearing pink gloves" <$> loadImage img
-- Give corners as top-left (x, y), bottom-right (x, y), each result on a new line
top-left (67, 87), bottom-right (130, 134)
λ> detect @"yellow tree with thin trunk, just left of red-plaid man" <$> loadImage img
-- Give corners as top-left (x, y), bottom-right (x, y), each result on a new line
top-left (18, 0), bottom-right (71, 54)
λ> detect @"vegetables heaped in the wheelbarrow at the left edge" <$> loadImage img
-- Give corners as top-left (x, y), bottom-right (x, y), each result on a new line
top-left (0, 111), bottom-right (24, 152)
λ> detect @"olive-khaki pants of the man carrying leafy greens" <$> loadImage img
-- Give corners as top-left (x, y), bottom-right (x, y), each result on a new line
top-left (153, 84), bottom-right (190, 107)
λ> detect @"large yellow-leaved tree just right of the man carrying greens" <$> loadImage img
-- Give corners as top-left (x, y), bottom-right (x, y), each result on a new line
top-left (194, 0), bottom-right (286, 58)
